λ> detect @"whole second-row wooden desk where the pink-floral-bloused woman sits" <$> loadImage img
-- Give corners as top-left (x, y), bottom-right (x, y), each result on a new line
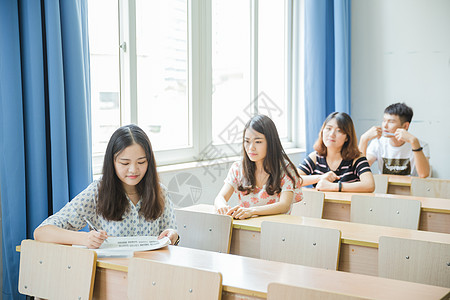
top-left (183, 204), bottom-right (450, 276)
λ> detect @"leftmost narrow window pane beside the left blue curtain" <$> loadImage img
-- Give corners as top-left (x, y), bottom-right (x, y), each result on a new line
top-left (88, 0), bottom-right (120, 173)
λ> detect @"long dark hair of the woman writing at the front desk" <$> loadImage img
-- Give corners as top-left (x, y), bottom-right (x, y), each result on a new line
top-left (97, 124), bottom-right (164, 221)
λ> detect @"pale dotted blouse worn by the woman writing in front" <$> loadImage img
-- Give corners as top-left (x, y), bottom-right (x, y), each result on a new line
top-left (39, 181), bottom-right (176, 237)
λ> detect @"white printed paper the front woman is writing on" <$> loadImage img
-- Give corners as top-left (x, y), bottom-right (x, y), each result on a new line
top-left (74, 236), bottom-right (170, 257)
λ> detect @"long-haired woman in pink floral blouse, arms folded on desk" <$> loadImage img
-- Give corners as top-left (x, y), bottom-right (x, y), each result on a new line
top-left (214, 115), bottom-right (302, 219)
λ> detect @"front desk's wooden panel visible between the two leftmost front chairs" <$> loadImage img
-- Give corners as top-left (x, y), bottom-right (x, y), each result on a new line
top-left (93, 268), bottom-right (128, 300)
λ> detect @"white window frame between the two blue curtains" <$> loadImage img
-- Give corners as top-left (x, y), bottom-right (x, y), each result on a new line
top-left (94, 0), bottom-right (305, 174)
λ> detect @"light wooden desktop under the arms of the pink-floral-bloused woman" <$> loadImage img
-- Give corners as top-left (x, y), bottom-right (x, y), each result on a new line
top-left (183, 204), bottom-right (450, 248)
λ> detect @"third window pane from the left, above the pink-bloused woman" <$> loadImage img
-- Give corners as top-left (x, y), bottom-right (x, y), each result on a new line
top-left (212, 0), bottom-right (251, 144)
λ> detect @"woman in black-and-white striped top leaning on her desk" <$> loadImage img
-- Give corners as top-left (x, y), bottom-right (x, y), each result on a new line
top-left (299, 112), bottom-right (375, 193)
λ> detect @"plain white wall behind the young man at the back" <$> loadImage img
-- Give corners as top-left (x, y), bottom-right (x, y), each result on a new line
top-left (351, 0), bottom-right (450, 178)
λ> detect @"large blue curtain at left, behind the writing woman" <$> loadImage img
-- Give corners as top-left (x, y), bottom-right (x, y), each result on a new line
top-left (0, 0), bottom-right (92, 299)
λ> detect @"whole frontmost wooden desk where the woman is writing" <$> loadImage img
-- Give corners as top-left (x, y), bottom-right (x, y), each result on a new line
top-left (93, 246), bottom-right (450, 300)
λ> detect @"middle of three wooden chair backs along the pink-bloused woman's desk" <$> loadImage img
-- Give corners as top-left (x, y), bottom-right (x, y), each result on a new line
top-left (260, 221), bottom-right (341, 270)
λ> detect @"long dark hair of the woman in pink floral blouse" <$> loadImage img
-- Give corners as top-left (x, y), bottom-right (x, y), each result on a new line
top-left (238, 115), bottom-right (301, 195)
